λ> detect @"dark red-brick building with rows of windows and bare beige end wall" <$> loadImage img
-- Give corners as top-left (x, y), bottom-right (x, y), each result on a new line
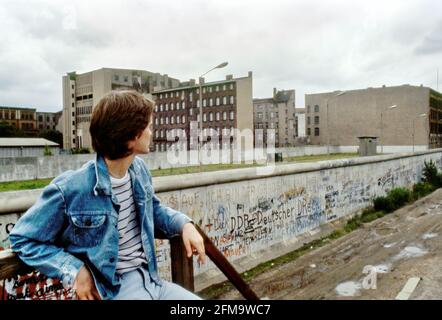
top-left (152, 72), bottom-right (253, 151)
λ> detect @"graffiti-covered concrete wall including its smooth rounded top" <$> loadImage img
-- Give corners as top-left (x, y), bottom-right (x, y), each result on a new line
top-left (0, 149), bottom-right (442, 290)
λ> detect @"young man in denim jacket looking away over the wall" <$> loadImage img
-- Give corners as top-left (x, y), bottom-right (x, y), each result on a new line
top-left (9, 91), bottom-right (205, 300)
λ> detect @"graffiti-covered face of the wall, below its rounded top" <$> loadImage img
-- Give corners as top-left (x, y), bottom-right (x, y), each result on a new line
top-left (0, 154), bottom-right (442, 299)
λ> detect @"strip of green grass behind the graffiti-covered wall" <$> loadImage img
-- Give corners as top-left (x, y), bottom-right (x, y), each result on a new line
top-left (0, 153), bottom-right (357, 192)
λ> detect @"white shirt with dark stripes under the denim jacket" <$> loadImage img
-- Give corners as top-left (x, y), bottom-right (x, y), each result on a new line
top-left (110, 171), bottom-right (147, 274)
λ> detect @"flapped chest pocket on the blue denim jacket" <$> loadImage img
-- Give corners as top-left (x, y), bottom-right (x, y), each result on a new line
top-left (69, 211), bottom-right (108, 247)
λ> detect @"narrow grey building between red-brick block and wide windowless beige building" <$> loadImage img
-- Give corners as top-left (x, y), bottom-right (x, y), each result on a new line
top-left (253, 88), bottom-right (297, 147)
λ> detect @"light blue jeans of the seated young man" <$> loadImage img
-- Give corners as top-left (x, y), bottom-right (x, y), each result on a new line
top-left (114, 268), bottom-right (201, 300)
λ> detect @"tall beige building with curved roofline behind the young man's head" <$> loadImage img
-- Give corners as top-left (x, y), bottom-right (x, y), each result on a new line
top-left (62, 68), bottom-right (180, 149)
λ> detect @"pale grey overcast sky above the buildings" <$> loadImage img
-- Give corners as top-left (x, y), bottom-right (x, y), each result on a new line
top-left (0, 0), bottom-right (442, 111)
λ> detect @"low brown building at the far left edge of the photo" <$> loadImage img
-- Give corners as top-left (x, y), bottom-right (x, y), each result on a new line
top-left (0, 106), bottom-right (37, 135)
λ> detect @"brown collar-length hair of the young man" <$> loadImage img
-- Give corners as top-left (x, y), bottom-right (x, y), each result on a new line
top-left (89, 90), bottom-right (154, 160)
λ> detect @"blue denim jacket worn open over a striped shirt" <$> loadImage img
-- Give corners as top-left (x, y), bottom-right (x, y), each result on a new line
top-left (9, 155), bottom-right (191, 299)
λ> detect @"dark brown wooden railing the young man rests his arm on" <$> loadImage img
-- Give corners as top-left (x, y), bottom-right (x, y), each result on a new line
top-left (0, 226), bottom-right (259, 300)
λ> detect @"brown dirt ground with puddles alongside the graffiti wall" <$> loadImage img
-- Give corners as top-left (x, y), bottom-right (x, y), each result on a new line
top-left (220, 189), bottom-right (442, 300)
